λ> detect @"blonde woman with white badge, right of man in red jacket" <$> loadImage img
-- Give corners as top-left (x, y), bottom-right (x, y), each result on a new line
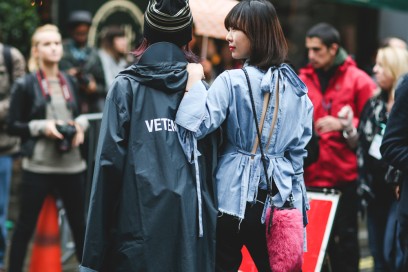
top-left (348, 47), bottom-right (408, 271)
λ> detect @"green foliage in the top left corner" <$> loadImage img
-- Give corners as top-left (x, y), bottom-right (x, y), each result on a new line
top-left (0, 0), bottom-right (40, 57)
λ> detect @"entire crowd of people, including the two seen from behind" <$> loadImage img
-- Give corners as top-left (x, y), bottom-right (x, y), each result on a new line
top-left (0, 0), bottom-right (408, 272)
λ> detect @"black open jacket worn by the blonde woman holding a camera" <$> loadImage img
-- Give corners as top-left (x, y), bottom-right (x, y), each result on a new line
top-left (7, 72), bottom-right (80, 156)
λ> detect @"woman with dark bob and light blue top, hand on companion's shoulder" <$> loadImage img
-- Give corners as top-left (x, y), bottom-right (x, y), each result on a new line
top-left (176, 0), bottom-right (313, 271)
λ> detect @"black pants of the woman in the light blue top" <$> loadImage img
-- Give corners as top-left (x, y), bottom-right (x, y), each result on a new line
top-left (216, 191), bottom-right (271, 272)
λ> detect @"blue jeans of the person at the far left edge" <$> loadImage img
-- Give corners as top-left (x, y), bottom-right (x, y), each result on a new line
top-left (0, 156), bottom-right (13, 268)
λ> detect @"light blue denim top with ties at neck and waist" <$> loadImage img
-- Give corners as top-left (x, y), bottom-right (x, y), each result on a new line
top-left (176, 64), bottom-right (313, 224)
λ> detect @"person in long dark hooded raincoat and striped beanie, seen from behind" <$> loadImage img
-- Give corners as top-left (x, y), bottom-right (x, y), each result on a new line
top-left (80, 0), bottom-right (217, 272)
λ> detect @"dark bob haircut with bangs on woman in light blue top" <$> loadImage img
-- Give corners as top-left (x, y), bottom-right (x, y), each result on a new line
top-left (224, 0), bottom-right (288, 70)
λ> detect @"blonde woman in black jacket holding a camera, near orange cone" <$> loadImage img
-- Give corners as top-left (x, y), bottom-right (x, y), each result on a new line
top-left (7, 25), bottom-right (88, 272)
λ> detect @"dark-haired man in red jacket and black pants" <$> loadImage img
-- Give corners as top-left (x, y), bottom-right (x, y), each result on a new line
top-left (300, 23), bottom-right (376, 272)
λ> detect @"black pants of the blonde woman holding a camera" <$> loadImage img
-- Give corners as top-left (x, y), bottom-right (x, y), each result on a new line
top-left (8, 171), bottom-right (85, 272)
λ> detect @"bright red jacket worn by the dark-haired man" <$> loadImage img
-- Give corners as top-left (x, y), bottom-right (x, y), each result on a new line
top-left (299, 57), bottom-right (376, 187)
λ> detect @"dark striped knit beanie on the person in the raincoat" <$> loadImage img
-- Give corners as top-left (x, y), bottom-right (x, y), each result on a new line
top-left (144, 0), bottom-right (193, 46)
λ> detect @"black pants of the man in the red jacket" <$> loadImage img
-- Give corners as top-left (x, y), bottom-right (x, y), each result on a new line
top-left (328, 182), bottom-right (360, 272)
